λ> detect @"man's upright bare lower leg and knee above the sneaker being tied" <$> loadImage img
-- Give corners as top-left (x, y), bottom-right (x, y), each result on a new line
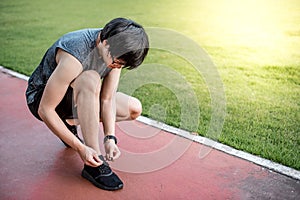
top-left (72, 71), bottom-right (101, 155)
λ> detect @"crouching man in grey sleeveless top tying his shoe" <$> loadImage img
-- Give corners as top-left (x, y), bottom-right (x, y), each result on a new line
top-left (26, 18), bottom-right (149, 190)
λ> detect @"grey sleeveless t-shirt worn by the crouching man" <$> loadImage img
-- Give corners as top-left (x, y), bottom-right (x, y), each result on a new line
top-left (26, 29), bottom-right (111, 104)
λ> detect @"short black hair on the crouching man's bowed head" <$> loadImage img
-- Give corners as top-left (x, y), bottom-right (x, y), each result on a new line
top-left (100, 18), bottom-right (149, 69)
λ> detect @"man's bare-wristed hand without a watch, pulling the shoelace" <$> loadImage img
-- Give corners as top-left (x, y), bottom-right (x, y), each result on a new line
top-left (78, 145), bottom-right (103, 167)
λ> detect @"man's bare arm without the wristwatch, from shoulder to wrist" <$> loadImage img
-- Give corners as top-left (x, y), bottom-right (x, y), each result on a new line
top-left (38, 50), bottom-right (83, 150)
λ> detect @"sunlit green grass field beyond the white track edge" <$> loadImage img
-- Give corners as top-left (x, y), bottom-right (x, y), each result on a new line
top-left (0, 0), bottom-right (300, 170)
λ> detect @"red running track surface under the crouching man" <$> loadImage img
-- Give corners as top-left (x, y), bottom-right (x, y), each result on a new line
top-left (0, 72), bottom-right (300, 200)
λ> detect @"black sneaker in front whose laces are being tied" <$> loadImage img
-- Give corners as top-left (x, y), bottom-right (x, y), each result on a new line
top-left (81, 156), bottom-right (123, 191)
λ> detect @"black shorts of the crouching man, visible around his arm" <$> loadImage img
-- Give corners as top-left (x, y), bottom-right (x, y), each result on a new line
top-left (28, 86), bottom-right (77, 121)
